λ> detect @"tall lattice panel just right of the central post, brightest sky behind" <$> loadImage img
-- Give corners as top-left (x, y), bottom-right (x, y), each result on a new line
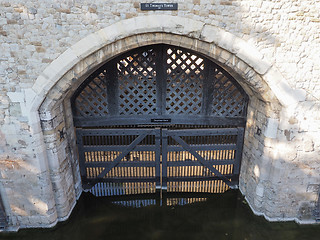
top-left (166, 48), bottom-right (204, 114)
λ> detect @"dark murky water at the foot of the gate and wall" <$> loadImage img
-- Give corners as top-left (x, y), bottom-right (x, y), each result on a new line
top-left (0, 191), bottom-right (320, 240)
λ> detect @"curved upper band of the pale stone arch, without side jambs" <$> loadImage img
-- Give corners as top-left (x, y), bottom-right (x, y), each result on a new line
top-left (31, 15), bottom-right (302, 113)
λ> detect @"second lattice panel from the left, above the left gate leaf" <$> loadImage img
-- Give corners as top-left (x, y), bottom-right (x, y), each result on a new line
top-left (117, 48), bottom-right (157, 115)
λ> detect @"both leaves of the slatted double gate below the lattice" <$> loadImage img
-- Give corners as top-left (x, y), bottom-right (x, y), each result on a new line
top-left (77, 128), bottom-right (243, 196)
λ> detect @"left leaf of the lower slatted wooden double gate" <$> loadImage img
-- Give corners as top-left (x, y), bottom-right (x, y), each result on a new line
top-left (77, 129), bottom-right (160, 195)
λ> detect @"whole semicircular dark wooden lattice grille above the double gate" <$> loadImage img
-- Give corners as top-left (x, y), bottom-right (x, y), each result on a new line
top-left (72, 45), bottom-right (248, 126)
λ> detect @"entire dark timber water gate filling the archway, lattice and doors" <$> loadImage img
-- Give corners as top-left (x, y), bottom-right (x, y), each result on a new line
top-left (72, 44), bottom-right (248, 196)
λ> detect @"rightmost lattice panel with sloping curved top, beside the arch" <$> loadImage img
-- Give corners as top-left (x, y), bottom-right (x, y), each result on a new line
top-left (211, 69), bottom-right (246, 117)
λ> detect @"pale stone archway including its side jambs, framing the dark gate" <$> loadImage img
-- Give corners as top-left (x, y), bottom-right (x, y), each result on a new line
top-left (26, 15), bottom-right (304, 224)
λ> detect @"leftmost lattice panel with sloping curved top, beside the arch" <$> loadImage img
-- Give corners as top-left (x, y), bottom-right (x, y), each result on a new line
top-left (75, 71), bottom-right (108, 117)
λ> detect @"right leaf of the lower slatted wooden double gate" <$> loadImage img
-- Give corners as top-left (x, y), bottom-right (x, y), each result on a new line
top-left (162, 128), bottom-right (243, 193)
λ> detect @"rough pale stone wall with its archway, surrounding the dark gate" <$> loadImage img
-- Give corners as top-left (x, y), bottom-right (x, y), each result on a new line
top-left (0, 0), bottom-right (320, 230)
